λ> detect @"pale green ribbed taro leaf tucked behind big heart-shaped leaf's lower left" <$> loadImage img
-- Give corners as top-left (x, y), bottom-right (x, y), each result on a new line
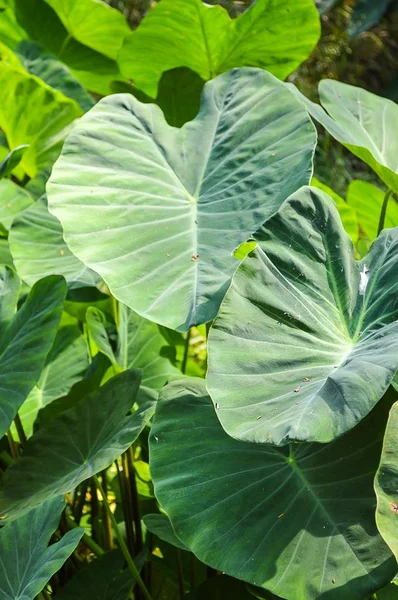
top-left (9, 192), bottom-right (100, 287)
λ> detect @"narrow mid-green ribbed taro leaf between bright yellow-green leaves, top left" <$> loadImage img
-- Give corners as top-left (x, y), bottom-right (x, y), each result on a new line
top-left (15, 40), bottom-right (94, 112)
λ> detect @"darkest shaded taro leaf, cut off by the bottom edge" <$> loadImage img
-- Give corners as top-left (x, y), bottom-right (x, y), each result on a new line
top-left (55, 550), bottom-right (133, 600)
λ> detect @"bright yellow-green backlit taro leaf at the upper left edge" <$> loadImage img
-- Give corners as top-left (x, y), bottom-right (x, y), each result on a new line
top-left (0, 62), bottom-right (82, 177)
